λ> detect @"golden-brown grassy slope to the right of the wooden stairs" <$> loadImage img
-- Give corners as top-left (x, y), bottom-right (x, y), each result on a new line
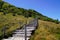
top-left (30, 20), bottom-right (60, 40)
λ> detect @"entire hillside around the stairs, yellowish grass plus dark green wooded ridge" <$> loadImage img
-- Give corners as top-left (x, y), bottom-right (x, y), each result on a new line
top-left (0, 0), bottom-right (60, 40)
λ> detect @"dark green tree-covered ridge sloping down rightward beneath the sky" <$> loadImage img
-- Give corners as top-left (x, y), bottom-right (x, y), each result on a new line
top-left (0, 1), bottom-right (59, 23)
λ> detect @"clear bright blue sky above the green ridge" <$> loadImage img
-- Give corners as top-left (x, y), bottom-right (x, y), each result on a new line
top-left (4, 0), bottom-right (60, 20)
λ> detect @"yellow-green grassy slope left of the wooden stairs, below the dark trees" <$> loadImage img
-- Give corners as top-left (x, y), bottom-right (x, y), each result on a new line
top-left (0, 12), bottom-right (32, 36)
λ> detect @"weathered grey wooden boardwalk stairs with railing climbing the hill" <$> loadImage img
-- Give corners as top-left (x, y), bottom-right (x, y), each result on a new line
top-left (2, 19), bottom-right (38, 40)
